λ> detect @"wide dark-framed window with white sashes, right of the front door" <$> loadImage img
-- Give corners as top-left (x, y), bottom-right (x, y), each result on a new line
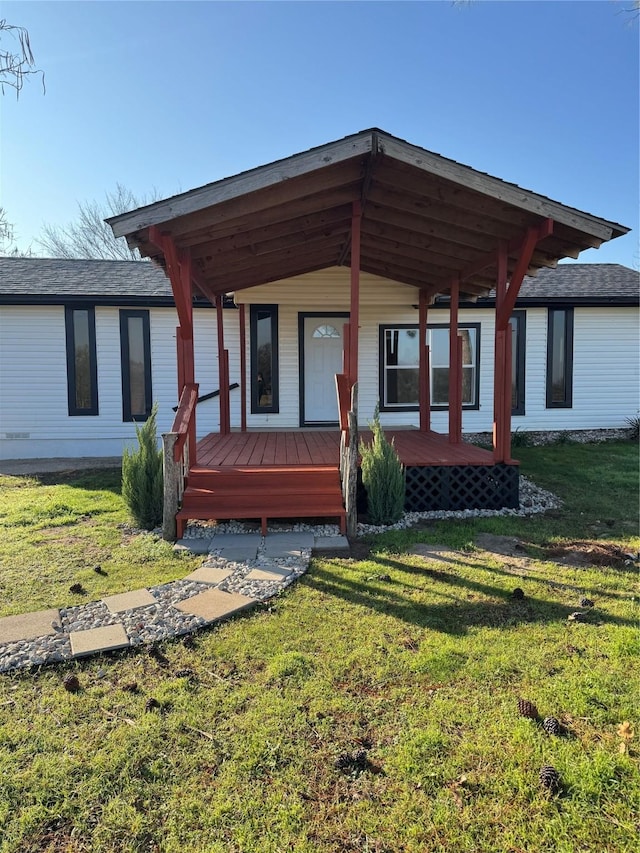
top-left (380, 323), bottom-right (480, 411)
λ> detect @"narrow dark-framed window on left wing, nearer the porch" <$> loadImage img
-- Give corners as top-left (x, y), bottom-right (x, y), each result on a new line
top-left (120, 311), bottom-right (153, 421)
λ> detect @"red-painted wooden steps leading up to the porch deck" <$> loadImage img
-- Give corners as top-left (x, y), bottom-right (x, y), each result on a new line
top-left (176, 465), bottom-right (346, 537)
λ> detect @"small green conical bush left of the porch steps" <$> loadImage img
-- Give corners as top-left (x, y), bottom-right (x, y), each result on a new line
top-left (122, 404), bottom-right (163, 530)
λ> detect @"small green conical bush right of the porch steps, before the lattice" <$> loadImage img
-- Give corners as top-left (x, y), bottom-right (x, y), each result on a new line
top-left (360, 406), bottom-right (405, 524)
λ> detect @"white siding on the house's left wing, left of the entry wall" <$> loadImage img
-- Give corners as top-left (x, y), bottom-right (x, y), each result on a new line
top-left (0, 305), bottom-right (240, 459)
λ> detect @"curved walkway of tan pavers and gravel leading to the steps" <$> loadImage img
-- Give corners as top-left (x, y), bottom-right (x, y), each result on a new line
top-left (0, 532), bottom-right (349, 672)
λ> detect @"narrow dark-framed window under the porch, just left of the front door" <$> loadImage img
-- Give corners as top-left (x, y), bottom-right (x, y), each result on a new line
top-left (249, 305), bottom-right (279, 414)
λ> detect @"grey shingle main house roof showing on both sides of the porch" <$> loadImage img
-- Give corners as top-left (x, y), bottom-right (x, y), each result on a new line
top-left (0, 258), bottom-right (640, 305)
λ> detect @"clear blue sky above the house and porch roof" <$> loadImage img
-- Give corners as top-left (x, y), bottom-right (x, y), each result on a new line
top-left (0, 0), bottom-right (640, 268)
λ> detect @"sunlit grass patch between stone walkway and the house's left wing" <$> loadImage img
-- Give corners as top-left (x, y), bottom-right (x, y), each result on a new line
top-left (0, 469), bottom-right (201, 616)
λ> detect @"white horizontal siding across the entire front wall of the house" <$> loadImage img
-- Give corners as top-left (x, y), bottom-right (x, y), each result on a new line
top-left (0, 268), bottom-right (640, 459)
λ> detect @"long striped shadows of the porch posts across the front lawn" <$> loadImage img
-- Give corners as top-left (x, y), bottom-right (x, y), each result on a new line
top-left (302, 558), bottom-right (635, 636)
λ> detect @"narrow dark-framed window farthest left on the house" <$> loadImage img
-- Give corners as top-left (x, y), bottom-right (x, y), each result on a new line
top-left (64, 307), bottom-right (98, 416)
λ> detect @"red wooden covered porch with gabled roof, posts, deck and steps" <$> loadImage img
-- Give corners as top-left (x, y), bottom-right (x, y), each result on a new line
top-left (109, 128), bottom-right (628, 537)
